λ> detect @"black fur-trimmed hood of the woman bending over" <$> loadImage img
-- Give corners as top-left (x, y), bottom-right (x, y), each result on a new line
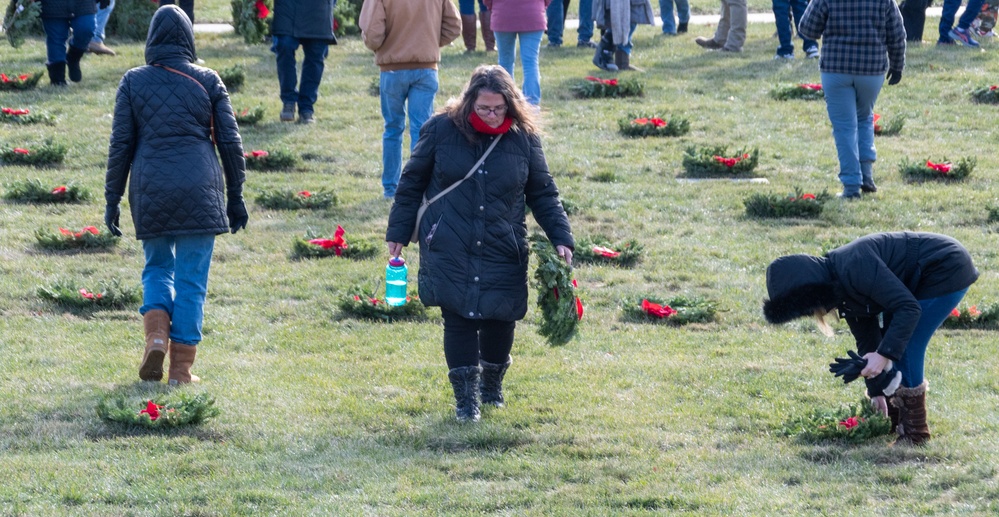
top-left (763, 255), bottom-right (840, 324)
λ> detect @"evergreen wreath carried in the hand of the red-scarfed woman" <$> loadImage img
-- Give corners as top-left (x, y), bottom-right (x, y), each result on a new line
top-left (531, 235), bottom-right (583, 346)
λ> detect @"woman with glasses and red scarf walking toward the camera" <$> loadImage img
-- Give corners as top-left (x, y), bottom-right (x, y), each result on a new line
top-left (385, 66), bottom-right (574, 421)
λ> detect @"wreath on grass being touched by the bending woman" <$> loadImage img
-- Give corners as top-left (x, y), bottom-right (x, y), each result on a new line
top-left (780, 399), bottom-right (892, 443)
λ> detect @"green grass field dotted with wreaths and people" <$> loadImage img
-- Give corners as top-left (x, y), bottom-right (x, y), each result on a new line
top-left (0, 12), bottom-right (999, 516)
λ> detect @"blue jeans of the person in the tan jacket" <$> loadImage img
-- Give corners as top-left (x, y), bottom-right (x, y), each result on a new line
top-left (378, 68), bottom-right (438, 197)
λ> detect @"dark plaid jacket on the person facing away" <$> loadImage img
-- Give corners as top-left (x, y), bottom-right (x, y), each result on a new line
top-left (798, 0), bottom-right (905, 75)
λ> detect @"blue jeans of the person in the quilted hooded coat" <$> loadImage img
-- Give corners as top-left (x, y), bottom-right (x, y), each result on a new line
top-left (139, 234), bottom-right (215, 345)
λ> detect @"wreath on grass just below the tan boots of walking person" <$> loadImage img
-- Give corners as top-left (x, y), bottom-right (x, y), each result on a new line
top-left (97, 391), bottom-right (221, 429)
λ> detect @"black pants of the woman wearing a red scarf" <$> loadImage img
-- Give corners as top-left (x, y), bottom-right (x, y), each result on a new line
top-left (441, 308), bottom-right (517, 369)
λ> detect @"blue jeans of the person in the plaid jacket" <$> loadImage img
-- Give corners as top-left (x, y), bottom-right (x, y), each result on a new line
top-left (821, 72), bottom-right (885, 194)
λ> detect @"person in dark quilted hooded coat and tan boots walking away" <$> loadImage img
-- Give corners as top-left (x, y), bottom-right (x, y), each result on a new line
top-left (104, 5), bottom-right (247, 384)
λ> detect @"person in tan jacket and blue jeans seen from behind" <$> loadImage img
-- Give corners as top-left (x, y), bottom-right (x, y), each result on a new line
top-left (358, 0), bottom-right (461, 200)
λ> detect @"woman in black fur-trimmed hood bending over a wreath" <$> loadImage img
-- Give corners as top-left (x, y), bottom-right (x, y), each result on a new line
top-left (763, 232), bottom-right (978, 445)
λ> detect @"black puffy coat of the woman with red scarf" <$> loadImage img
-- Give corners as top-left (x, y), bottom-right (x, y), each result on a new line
top-left (386, 115), bottom-right (574, 321)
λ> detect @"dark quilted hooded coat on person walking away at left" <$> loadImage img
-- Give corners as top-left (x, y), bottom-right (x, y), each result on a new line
top-left (104, 5), bottom-right (246, 239)
